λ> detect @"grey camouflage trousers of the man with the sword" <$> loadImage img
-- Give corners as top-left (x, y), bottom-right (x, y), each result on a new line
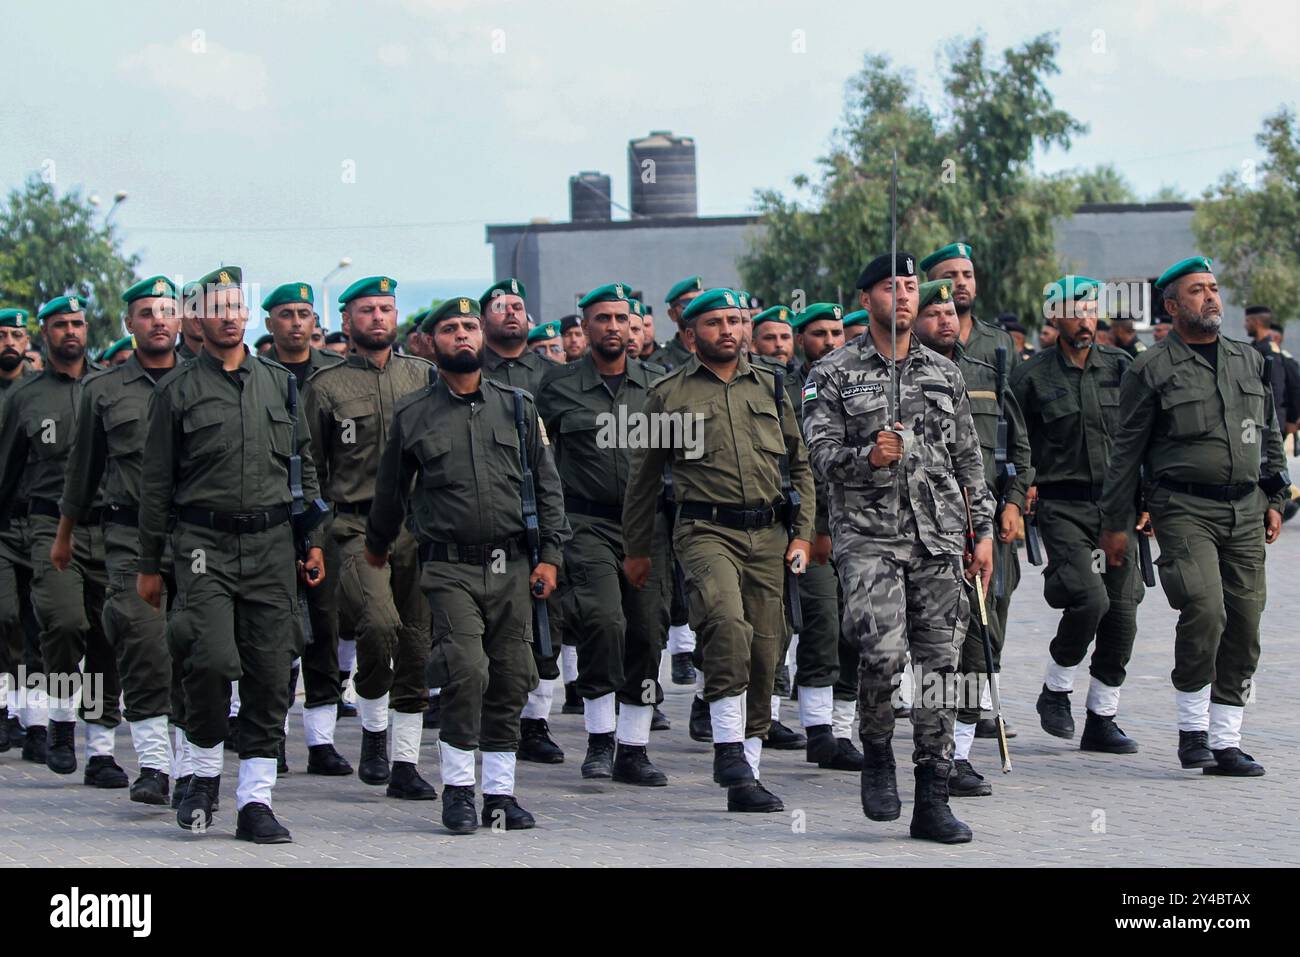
top-left (835, 534), bottom-right (970, 765)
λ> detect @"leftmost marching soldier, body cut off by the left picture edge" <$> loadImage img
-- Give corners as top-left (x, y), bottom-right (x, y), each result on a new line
top-left (0, 308), bottom-right (49, 765)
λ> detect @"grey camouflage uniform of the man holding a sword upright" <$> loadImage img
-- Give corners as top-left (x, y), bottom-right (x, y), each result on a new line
top-left (803, 335), bottom-right (993, 763)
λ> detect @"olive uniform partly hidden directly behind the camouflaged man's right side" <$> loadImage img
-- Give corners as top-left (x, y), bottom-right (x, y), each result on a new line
top-left (953, 345), bottom-right (1034, 722)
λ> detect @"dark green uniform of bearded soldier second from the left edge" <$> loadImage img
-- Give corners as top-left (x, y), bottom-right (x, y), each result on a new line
top-left (0, 361), bottom-right (121, 728)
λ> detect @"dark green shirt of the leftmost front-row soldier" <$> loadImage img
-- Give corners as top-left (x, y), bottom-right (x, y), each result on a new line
top-left (140, 347), bottom-right (320, 575)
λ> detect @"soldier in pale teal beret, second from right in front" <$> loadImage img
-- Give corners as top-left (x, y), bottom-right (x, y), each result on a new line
top-left (1011, 276), bottom-right (1145, 754)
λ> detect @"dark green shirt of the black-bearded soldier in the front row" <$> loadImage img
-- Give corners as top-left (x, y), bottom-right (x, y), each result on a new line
top-left (365, 377), bottom-right (572, 567)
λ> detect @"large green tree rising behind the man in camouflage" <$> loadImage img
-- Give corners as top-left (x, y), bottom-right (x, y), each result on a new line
top-left (738, 35), bottom-right (1087, 325)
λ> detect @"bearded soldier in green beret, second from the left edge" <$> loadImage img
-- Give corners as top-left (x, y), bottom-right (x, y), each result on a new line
top-left (0, 295), bottom-right (122, 788)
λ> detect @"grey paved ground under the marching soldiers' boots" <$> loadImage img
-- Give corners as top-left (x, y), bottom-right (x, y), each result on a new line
top-left (0, 524), bottom-right (1300, 867)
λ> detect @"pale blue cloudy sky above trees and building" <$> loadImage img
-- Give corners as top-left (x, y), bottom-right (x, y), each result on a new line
top-left (0, 0), bottom-right (1300, 306)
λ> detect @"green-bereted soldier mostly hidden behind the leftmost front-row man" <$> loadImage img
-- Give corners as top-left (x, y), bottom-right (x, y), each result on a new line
top-left (261, 282), bottom-right (352, 776)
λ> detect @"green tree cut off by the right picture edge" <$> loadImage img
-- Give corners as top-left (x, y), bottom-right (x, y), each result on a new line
top-left (1192, 107), bottom-right (1300, 322)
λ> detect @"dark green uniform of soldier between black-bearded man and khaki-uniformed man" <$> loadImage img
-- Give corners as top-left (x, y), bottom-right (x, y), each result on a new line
top-left (537, 354), bottom-right (668, 728)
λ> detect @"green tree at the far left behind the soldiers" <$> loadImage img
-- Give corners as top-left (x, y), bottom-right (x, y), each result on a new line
top-left (0, 176), bottom-right (139, 346)
